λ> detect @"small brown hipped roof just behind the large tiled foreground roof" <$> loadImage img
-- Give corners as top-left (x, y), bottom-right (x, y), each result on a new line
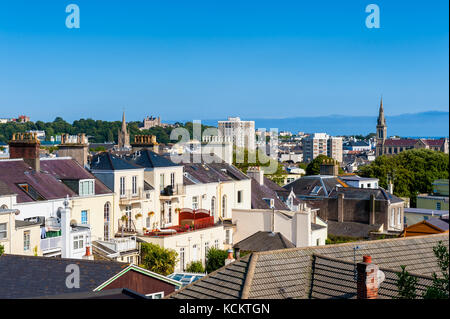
top-left (233, 231), bottom-right (295, 251)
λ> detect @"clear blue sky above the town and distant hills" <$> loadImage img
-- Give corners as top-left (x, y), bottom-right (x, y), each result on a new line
top-left (0, 0), bottom-right (449, 121)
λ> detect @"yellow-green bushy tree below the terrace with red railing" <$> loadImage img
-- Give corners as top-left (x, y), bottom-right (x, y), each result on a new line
top-left (141, 243), bottom-right (178, 276)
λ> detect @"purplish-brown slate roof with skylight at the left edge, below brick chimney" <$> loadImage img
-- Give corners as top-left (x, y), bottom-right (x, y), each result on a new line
top-left (0, 160), bottom-right (77, 203)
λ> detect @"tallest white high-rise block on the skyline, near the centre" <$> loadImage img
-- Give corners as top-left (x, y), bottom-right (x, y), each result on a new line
top-left (218, 117), bottom-right (256, 150)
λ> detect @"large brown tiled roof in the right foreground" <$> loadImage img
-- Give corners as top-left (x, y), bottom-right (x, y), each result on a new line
top-left (167, 233), bottom-right (449, 299)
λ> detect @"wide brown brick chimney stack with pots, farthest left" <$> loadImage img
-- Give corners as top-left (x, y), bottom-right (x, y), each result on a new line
top-left (9, 133), bottom-right (41, 172)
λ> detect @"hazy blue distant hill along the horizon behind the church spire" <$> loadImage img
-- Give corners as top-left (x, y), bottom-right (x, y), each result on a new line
top-left (202, 111), bottom-right (449, 137)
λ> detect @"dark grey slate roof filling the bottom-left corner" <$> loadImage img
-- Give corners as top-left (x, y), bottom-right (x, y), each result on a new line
top-left (0, 254), bottom-right (128, 299)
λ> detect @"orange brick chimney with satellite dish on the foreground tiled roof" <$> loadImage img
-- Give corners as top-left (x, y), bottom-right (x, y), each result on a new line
top-left (356, 256), bottom-right (384, 299)
